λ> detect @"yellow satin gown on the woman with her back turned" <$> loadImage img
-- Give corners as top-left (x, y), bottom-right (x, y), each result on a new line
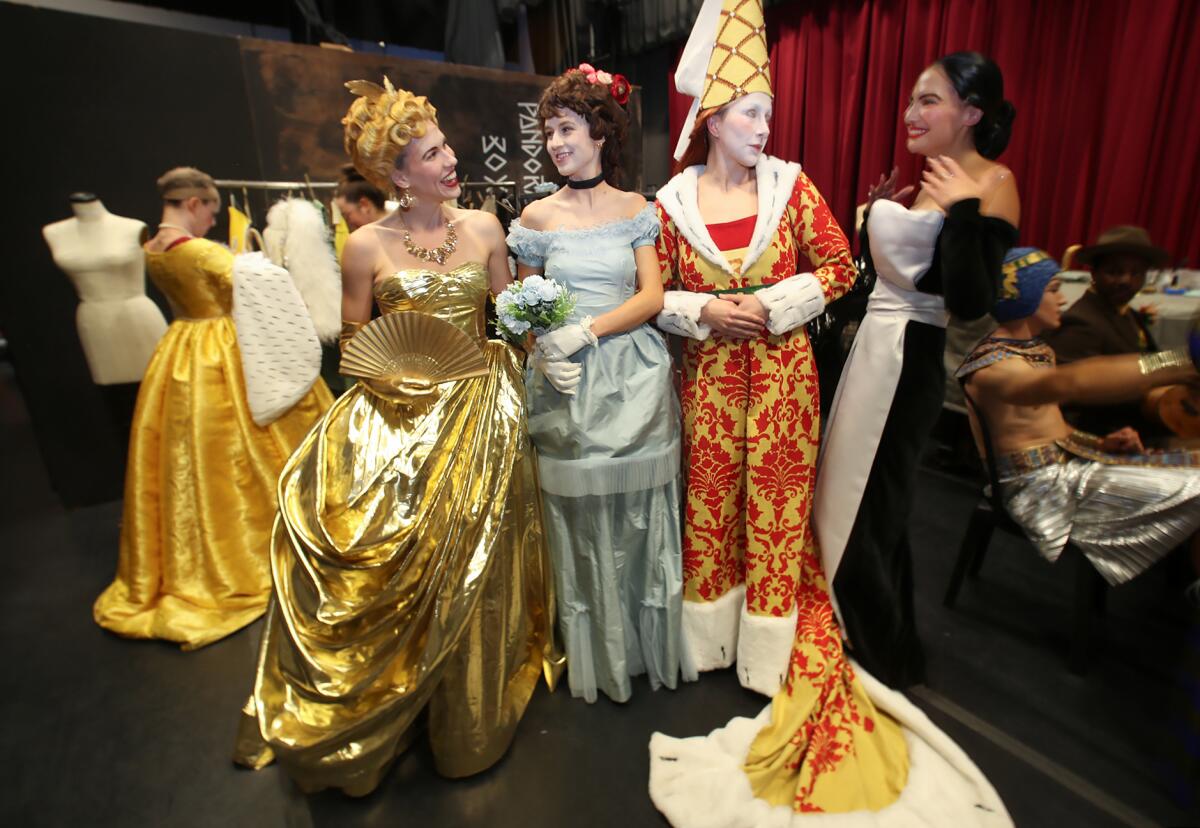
top-left (92, 239), bottom-right (332, 649)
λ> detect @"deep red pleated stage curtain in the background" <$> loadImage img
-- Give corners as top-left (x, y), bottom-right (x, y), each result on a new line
top-left (670, 0), bottom-right (1200, 266)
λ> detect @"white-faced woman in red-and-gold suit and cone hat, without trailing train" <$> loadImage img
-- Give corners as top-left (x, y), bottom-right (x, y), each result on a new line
top-left (658, 0), bottom-right (856, 696)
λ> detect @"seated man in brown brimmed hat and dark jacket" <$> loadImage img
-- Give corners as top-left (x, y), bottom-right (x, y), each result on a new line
top-left (1045, 224), bottom-right (1169, 438)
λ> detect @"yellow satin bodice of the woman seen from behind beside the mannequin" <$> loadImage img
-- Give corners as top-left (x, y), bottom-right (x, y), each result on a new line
top-left (146, 239), bottom-right (233, 319)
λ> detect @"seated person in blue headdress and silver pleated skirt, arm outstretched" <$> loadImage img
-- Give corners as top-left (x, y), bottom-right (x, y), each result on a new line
top-left (956, 247), bottom-right (1200, 605)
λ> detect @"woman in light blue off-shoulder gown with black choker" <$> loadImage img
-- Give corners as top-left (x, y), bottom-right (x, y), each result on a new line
top-left (509, 65), bottom-right (696, 702)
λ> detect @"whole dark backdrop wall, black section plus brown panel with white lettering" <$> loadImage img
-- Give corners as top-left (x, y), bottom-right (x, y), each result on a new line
top-left (0, 4), bottom-right (642, 506)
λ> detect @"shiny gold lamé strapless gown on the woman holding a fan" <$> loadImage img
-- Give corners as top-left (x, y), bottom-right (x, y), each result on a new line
top-left (235, 263), bottom-right (563, 794)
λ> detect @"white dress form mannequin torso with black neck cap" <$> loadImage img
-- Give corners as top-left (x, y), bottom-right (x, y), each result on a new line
top-left (42, 193), bottom-right (167, 385)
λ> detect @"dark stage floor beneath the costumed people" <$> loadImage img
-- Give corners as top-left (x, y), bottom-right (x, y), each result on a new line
top-left (0, 364), bottom-right (1200, 828)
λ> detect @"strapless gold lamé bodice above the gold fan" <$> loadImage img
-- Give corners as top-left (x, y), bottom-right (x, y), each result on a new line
top-left (374, 262), bottom-right (488, 342)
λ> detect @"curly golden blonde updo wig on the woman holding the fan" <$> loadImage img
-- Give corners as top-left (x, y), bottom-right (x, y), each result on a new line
top-left (342, 77), bottom-right (438, 193)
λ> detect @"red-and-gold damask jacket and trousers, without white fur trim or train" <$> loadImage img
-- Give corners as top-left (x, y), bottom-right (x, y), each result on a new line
top-left (659, 164), bottom-right (854, 617)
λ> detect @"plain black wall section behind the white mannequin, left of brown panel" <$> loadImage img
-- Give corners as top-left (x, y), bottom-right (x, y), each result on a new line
top-left (0, 4), bottom-right (260, 506)
